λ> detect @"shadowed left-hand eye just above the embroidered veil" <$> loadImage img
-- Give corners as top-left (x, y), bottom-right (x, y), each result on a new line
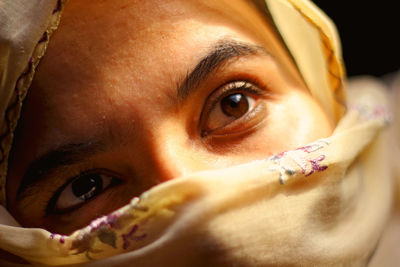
top-left (47, 173), bottom-right (118, 213)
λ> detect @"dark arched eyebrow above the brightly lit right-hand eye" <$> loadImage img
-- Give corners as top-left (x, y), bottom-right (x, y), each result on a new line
top-left (177, 39), bottom-right (271, 100)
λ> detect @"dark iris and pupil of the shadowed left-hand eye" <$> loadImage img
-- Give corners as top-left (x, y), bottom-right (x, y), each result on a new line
top-left (71, 175), bottom-right (103, 200)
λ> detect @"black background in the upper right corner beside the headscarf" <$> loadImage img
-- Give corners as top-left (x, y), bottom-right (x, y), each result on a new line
top-left (314, 0), bottom-right (400, 77)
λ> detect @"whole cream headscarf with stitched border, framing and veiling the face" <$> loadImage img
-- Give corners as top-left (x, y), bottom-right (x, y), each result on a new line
top-left (0, 0), bottom-right (393, 266)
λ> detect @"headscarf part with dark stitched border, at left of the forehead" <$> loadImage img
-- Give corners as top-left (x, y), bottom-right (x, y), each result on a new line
top-left (0, 0), bottom-right (65, 207)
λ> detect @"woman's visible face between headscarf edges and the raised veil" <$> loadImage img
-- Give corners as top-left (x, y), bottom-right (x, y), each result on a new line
top-left (8, 0), bottom-right (332, 233)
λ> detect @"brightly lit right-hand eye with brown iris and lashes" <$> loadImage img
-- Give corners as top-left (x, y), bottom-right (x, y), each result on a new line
top-left (201, 81), bottom-right (267, 137)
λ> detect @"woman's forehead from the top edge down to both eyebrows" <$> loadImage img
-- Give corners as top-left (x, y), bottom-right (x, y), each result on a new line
top-left (17, 0), bottom-right (296, 147)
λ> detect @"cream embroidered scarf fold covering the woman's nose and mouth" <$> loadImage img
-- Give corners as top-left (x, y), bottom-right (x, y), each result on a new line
top-left (0, 83), bottom-right (391, 265)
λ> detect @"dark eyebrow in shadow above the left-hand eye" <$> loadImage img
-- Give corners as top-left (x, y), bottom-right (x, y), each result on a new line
top-left (16, 142), bottom-right (105, 199)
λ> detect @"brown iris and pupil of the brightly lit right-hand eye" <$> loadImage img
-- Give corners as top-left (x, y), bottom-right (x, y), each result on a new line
top-left (221, 93), bottom-right (249, 118)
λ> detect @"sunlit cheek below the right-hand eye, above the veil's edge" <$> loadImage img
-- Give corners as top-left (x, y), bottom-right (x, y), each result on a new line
top-left (228, 92), bottom-right (333, 161)
